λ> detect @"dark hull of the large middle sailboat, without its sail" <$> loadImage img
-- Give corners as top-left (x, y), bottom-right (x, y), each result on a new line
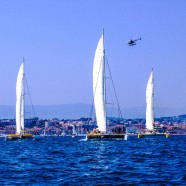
top-left (87, 134), bottom-right (125, 139)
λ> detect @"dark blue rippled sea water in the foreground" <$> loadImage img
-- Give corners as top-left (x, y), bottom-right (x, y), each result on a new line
top-left (0, 136), bottom-right (186, 185)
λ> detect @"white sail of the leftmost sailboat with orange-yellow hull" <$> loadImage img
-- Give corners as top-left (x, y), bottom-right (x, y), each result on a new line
top-left (16, 63), bottom-right (24, 134)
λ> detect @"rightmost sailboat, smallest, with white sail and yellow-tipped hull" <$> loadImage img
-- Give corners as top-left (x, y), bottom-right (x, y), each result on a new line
top-left (138, 69), bottom-right (169, 138)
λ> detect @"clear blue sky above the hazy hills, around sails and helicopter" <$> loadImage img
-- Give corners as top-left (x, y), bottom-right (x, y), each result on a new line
top-left (0, 0), bottom-right (186, 113)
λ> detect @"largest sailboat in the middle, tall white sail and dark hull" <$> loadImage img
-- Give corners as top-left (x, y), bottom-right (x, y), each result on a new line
top-left (87, 31), bottom-right (124, 139)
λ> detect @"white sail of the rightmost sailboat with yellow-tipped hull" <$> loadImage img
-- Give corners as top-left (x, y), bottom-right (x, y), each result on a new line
top-left (146, 70), bottom-right (154, 131)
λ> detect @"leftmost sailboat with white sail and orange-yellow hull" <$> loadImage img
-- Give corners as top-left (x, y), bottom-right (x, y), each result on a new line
top-left (5, 61), bottom-right (34, 140)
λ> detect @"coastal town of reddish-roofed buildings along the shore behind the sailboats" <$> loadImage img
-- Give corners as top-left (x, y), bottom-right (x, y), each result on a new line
top-left (0, 115), bottom-right (186, 136)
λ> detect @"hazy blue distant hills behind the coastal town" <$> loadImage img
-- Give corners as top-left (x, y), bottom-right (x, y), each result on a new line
top-left (0, 103), bottom-right (186, 119)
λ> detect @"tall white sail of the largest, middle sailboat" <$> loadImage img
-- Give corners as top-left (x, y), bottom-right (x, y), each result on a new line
top-left (93, 31), bottom-right (106, 132)
